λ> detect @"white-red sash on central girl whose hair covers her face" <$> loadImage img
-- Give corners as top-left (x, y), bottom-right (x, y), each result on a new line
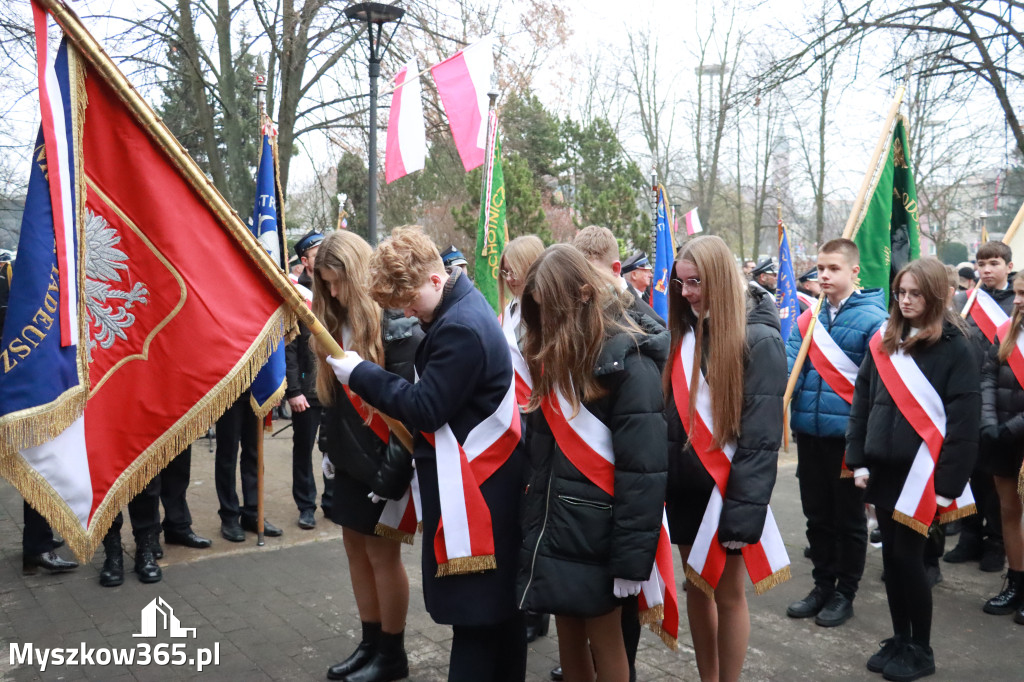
top-left (541, 392), bottom-right (679, 649)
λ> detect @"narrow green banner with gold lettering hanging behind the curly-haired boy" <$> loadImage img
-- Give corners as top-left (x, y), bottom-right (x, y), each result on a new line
top-left (473, 130), bottom-right (508, 313)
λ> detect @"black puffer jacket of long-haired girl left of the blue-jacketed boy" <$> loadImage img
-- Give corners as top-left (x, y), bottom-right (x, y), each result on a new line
top-left (665, 288), bottom-right (786, 544)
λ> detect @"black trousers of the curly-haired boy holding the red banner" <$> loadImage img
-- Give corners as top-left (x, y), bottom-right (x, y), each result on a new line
top-left (449, 613), bottom-right (526, 682)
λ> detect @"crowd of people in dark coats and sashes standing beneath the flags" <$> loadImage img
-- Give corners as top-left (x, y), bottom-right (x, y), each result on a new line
top-left (8, 226), bottom-right (1024, 682)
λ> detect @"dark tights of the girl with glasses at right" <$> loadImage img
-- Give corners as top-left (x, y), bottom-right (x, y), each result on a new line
top-left (878, 509), bottom-right (932, 646)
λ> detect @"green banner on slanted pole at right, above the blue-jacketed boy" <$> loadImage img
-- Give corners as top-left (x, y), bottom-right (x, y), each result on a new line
top-left (854, 117), bottom-right (921, 301)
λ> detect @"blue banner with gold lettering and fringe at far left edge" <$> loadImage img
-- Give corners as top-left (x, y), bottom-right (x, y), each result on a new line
top-left (0, 42), bottom-right (89, 455)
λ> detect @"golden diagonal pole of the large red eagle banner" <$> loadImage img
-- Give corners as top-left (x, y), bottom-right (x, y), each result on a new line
top-left (37, 0), bottom-right (413, 452)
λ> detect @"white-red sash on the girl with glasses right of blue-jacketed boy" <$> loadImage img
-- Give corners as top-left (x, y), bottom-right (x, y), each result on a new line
top-left (869, 325), bottom-right (974, 536)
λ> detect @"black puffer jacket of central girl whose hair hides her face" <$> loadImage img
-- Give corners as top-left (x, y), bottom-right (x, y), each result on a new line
top-left (517, 313), bottom-right (669, 617)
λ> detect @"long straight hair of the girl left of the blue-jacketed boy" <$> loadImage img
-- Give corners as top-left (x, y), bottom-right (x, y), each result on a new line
top-left (663, 236), bottom-right (746, 446)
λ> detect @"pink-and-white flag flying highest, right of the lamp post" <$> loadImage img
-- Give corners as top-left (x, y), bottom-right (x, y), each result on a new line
top-left (430, 38), bottom-right (495, 171)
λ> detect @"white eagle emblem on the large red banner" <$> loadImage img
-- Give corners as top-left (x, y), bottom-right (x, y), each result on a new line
top-left (85, 208), bottom-right (150, 363)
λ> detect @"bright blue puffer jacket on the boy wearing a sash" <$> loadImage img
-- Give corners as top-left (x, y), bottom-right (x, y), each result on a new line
top-left (785, 289), bottom-right (889, 438)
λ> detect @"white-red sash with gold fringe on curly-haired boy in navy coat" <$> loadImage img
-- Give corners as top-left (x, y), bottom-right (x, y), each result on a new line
top-left (422, 380), bottom-right (522, 578)
